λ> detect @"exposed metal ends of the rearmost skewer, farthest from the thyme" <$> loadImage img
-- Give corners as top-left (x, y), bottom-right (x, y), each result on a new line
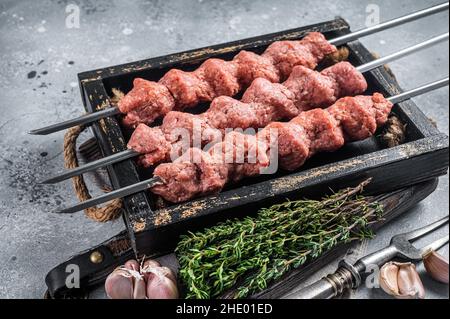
top-left (28, 2), bottom-right (449, 135)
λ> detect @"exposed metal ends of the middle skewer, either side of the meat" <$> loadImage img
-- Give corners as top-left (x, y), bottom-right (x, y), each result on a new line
top-left (42, 32), bottom-right (449, 184)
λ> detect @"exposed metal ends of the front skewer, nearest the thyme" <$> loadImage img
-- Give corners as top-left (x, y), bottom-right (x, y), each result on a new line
top-left (56, 77), bottom-right (449, 214)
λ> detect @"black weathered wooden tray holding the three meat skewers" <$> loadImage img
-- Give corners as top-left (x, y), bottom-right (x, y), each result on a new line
top-left (79, 18), bottom-right (449, 256)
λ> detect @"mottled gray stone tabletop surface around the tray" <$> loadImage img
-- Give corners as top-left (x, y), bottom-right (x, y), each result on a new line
top-left (0, 0), bottom-right (449, 298)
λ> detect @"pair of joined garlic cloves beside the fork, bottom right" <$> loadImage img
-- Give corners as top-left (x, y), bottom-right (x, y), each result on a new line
top-left (380, 262), bottom-right (425, 299)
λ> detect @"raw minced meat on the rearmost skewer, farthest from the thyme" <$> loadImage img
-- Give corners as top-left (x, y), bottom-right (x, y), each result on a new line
top-left (118, 32), bottom-right (336, 127)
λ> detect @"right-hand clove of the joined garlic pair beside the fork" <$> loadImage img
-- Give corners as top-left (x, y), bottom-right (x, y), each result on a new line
top-left (397, 263), bottom-right (425, 299)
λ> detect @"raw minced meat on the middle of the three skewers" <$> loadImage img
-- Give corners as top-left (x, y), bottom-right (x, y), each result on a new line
top-left (128, 62), bottom-right (367, 167)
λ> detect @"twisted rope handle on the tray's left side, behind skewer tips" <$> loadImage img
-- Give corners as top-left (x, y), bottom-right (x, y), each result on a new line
top-left (64, 126), bottom-right (123, 222)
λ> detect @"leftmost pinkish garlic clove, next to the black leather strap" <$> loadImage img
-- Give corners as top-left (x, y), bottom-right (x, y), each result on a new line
top-left (105, 268), bottom-right (134, 299)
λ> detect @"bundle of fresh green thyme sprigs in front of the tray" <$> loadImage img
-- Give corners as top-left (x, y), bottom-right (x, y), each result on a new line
top-left (175, 183), bottom-right (382, 299)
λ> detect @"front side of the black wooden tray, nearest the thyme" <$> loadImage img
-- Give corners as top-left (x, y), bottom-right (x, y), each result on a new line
top-left (130, 135), bottom-right (448, 255)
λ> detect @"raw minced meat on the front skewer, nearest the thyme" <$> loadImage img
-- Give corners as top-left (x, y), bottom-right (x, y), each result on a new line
top-left (152, 93), bottom-right (392, 202)
